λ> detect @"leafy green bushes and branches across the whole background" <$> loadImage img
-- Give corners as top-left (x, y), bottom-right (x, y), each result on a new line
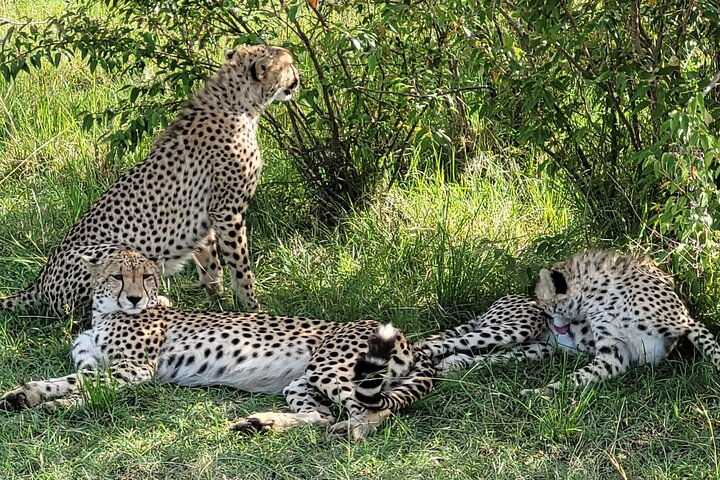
top-left (5, 0), bottom-right (720, 304)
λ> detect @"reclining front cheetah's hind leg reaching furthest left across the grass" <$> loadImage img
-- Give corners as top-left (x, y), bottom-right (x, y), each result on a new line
top-left (230, 376), bottom-right (335, 433)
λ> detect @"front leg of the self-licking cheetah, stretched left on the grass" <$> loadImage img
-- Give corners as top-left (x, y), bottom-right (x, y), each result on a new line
top-left (520, 337), bottom-right (630, 396)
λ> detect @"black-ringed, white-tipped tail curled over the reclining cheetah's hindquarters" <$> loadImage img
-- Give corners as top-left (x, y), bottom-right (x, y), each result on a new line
top-left (353, 324), bottom-right (420, 408)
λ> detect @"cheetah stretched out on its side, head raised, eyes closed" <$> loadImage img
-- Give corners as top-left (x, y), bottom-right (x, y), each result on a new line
top-left (0, 251), bottom-right (434, 439)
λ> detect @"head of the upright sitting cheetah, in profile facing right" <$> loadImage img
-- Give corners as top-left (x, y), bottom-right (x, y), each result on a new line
top-left (218, 45), bottom-right (300, 108)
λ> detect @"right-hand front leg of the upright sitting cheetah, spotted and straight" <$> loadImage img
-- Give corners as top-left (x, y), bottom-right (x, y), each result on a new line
top-left (213, 213), bottom-right (259, 311)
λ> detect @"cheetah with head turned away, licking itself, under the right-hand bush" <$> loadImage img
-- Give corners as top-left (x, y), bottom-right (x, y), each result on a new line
top-left (420, 250), bottom-right (720, 395)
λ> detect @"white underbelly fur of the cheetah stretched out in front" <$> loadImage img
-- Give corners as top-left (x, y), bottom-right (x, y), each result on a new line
top-left (155, 351), bottom-right (310, 394)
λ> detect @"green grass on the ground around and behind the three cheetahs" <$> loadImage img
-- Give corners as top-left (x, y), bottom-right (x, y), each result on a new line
top-left (0, 1), bottom-right (720, 480)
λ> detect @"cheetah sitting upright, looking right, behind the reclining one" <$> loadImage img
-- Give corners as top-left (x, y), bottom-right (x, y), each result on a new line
top-left (0, 45), bottom-right (299, 315)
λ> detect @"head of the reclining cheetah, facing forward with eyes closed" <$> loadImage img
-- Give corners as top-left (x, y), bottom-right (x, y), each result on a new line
top-left (82, 250), bottom-right (160, 314)
